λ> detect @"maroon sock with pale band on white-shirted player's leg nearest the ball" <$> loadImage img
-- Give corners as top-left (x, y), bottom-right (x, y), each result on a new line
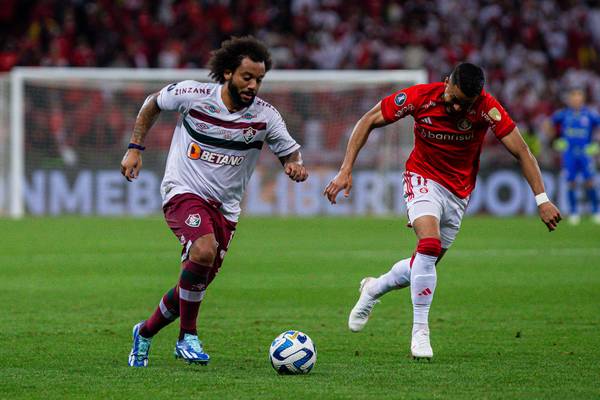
top-left (179, 260), bottom-right (212, 340)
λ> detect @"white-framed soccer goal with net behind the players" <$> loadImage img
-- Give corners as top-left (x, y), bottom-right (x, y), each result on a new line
top-left (0, 68), bottom-right (426, 217)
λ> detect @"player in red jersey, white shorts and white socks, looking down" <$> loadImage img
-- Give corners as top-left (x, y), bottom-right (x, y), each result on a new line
top-left (324, 63), bottom-right (561, 359)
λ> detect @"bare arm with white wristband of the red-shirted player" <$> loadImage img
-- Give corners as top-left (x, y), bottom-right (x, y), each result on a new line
top-left (502, 127), bottom-right (562, 231)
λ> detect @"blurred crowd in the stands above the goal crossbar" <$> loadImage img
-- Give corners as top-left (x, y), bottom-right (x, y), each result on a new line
top-left (0, 0), bottom-right (600, 169)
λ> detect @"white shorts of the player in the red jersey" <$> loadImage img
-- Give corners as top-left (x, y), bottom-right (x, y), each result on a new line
top-left (403, 171), bottom-right (469, 249)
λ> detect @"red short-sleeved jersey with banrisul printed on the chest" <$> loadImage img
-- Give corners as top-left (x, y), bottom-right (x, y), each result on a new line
top-left (381, 82), bottom-right (515, 198)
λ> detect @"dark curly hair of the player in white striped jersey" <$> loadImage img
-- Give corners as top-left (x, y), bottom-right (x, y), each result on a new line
top-left (208, 36), bottom-right (273, 83)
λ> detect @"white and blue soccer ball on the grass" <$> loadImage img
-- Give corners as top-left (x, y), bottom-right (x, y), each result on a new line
top-left (269, 331), bottom-right (317, 375)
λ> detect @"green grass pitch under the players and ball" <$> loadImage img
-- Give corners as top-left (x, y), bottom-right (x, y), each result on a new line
top-left (0, 216), bottom-right (600, 399)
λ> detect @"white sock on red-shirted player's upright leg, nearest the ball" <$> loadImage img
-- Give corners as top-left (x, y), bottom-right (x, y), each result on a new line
top-left (410, 253), bottom-right (437, 332)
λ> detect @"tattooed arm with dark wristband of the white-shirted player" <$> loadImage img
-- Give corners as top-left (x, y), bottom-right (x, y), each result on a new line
top-left (121, 93), bottom-right (160, 182)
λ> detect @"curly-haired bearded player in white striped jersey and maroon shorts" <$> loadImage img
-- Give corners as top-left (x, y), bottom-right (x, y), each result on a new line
top-left (121, 37), bottom-right (308, 367)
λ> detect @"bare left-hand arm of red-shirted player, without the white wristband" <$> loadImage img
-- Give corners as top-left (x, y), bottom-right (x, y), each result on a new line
top-left (323, 102), bottom-right (389, 204)
